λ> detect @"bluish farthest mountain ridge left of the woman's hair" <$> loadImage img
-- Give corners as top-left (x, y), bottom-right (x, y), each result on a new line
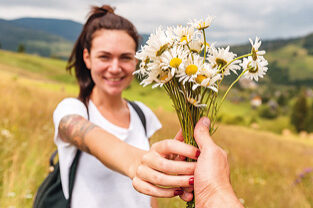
top-left (9, 18), bottom-right (83, 42)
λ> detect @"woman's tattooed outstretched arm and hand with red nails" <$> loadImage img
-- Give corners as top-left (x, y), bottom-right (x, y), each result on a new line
top-left (58, 115), bottom-right (198, 200)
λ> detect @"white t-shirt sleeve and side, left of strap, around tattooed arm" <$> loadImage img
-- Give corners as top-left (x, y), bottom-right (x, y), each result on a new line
top-left (53, 98), bottom-right (88, 199)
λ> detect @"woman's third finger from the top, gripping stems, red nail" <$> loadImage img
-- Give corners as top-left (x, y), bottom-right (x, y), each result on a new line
top-left (136, 165), bottom-right (194, 187)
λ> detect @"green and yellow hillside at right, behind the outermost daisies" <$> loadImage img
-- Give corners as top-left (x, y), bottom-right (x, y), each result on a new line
top-left (231, 33), bottom-right (313, 86)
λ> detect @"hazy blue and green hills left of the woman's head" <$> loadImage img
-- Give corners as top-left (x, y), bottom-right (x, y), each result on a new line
top-left (0, 18), bottom-right (149, 59)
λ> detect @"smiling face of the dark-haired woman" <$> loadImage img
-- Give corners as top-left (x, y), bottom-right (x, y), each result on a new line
top-left (84, 29), bottom-right (137, 96)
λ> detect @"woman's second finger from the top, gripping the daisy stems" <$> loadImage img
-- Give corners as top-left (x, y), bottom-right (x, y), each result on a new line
top-left (141, 152), bottom-right (196, 175)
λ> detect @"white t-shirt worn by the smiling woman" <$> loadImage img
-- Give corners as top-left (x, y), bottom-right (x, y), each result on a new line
top-left (53, 98), bottom-right (161, 208)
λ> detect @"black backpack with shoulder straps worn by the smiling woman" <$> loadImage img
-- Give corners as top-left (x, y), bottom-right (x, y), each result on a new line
top-left (33, 101), bottom-right (147, 208)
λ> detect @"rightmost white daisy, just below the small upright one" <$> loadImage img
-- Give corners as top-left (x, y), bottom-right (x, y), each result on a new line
top-left (240, 56), bottom-right (268, 81)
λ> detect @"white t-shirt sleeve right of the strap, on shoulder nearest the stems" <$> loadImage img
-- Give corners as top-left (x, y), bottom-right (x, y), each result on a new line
top-left (136, 101), bottom-right (162, 138)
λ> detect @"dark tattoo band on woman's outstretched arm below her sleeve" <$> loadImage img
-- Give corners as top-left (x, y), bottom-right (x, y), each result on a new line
top-left (59, 115), bottom-right (96, 153)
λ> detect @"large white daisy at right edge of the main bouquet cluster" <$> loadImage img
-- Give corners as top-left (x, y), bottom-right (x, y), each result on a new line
top-left (207, 46), bottom-right (240, 76)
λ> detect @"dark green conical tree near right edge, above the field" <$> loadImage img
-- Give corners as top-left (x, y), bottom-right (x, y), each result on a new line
top-left (291, 93), bottom-right (308, 132)
